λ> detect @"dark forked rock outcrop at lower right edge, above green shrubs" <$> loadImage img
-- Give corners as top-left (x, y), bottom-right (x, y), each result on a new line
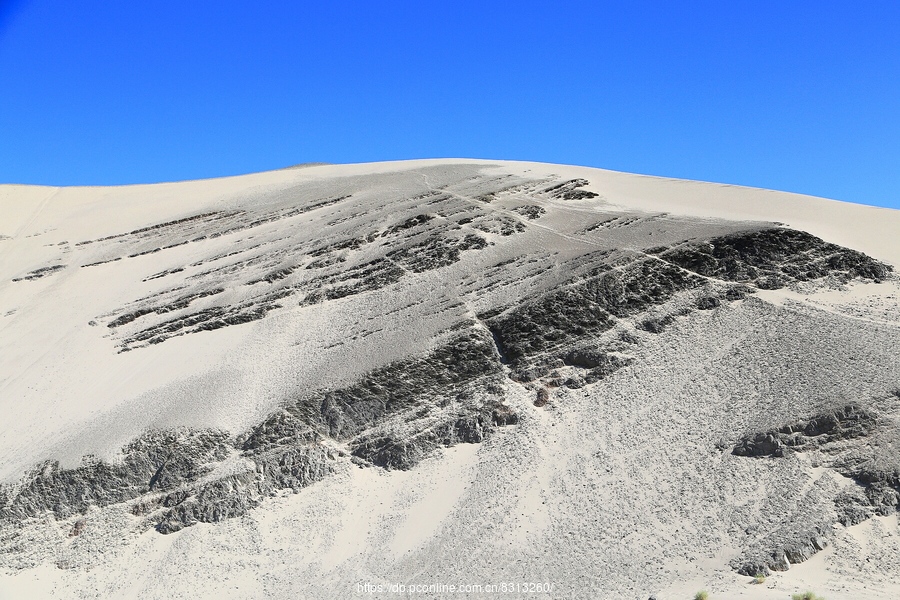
top-left (732, 404), bottom-right (900, 575)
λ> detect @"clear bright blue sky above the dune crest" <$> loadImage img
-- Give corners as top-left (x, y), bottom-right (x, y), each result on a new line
top-left (0, 0), bottom-right (900, 207)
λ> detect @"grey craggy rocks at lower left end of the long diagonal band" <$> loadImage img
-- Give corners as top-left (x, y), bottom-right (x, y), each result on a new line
top-left (0, 431), bottom-right (335, 533)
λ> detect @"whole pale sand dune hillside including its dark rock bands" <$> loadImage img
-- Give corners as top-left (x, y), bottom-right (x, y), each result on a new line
top-left (0, 161), bottom-right (900, 597)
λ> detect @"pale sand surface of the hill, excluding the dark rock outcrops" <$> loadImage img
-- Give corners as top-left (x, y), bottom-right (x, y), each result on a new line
top-left (0, 160), bottom-right (900, 600)
